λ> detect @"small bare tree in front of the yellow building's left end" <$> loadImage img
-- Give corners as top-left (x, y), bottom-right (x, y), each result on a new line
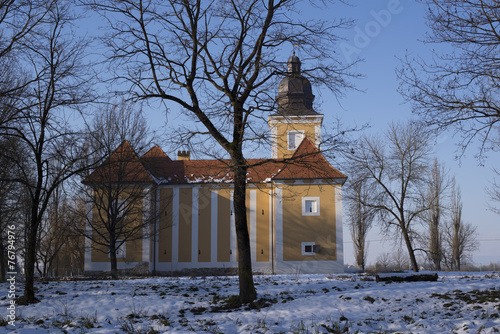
top-left (74, 100), bottom-right (155, 279)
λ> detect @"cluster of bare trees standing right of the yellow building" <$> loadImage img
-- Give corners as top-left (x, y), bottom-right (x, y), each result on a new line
top-left (344, 122), bottom-right (478, 271)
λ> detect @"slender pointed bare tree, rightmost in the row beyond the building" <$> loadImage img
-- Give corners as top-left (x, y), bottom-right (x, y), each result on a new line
top-left (444, 179), bottom-right (478, 270)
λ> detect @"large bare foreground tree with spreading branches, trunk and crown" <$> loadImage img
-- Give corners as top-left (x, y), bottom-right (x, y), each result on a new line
top-left (88, 0), bottom-right (354, 302)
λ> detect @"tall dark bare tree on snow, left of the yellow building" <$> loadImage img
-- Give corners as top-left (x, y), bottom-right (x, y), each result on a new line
top-left (1, 0), bottom-right (92, 303)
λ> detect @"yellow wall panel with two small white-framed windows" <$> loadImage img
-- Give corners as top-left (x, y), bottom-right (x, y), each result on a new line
top-left (283, 184), bottom-right (337, 261)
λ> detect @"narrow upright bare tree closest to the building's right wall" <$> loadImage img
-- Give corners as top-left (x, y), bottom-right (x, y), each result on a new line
top-left (344, 180), bottom-right (375, 270)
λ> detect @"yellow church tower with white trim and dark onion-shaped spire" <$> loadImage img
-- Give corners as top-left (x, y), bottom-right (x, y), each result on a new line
top-left (268, 52), bottom-right (323, 159)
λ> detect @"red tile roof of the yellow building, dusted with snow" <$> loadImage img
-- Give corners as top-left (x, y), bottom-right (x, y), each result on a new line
top-left (86, 138), bottom-right (346, 184)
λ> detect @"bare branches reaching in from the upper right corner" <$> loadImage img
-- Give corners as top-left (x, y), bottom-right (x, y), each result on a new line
top-left (399, 0), bottom-right (500, 157)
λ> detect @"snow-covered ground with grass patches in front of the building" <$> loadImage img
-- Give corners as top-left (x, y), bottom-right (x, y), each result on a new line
top-left (0, 272), bottom-right (500, 334)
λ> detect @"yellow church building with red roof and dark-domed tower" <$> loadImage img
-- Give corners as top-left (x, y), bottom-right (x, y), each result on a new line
top-left (84, 55), bottom-right (346, 274)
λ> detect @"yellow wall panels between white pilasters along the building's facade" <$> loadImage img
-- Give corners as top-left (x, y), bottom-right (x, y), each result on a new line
top-left (91, 180), bottom-right (338, 268)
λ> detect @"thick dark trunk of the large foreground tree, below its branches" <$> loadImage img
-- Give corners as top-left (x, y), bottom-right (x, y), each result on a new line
top-left (233, 159), bottom-right (257, 303)
